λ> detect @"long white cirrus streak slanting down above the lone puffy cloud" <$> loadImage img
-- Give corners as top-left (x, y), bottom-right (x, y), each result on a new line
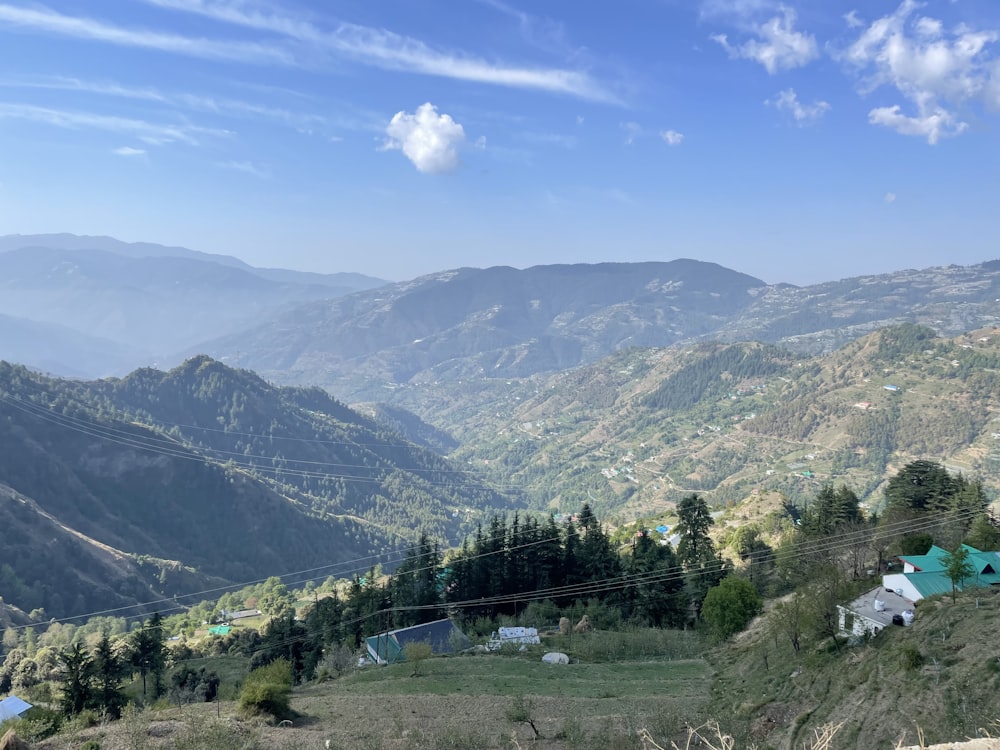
top-left (137, 0), bottom-right (618, 103)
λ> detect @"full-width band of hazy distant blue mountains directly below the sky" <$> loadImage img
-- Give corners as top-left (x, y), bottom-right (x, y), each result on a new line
top-left (0, 235), bottom-right (1000, 401)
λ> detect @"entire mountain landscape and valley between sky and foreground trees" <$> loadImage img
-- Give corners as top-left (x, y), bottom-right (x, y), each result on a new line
top-left (0, 235), bottom-right (1000, 624)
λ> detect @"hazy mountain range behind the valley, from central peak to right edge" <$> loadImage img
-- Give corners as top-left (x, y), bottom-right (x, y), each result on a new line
top-left (195, 260), bottom-right (1000, 402)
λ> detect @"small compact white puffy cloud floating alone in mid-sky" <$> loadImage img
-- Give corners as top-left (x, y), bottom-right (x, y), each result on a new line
top-left (382, 102), bottom-right (465, 174)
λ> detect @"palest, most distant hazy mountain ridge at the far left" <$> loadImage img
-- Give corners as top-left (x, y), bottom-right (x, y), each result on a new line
top-left (0, 235), bottom-right (384, 377)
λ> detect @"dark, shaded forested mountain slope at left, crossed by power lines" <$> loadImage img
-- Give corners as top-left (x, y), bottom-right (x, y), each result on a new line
top-left (0, 358), bottom-right (506, 614)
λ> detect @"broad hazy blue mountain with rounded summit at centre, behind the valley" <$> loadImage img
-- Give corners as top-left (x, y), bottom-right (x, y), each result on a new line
top-left (197, 260), bottom-right (766, 401)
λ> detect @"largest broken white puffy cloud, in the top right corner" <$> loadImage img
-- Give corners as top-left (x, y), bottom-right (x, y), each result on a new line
top-left (836, 0), bottom-right (1000, 144)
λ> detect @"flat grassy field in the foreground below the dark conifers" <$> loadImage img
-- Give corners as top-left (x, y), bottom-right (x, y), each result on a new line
top-left (36, 631), bottom-right (712, 750)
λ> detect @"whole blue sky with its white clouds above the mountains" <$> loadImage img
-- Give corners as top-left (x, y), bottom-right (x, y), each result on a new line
top-left (0, 0), bottom-right (1000, 283)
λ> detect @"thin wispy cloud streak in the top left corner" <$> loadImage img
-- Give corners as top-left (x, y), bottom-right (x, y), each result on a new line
top-left (0, 4), bottom-right (295, 65)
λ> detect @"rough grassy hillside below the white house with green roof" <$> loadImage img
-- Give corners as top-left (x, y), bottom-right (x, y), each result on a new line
top-left (708, 591), bottom-right (1000, 750)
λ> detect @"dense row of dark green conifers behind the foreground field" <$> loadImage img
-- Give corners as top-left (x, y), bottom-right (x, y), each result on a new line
top-left (220, 495), bottom-right (744, 681)
